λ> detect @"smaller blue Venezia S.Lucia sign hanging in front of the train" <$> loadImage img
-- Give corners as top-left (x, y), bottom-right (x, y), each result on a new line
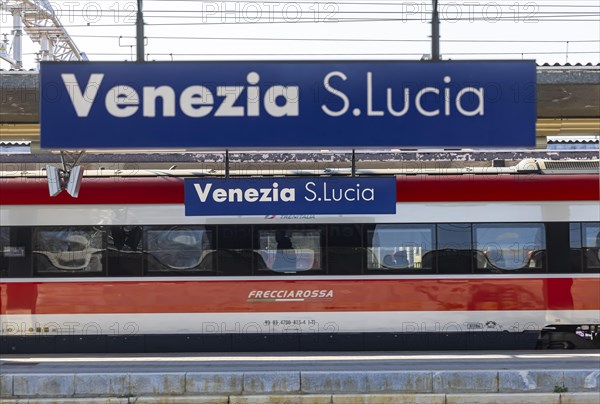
top-left (185, 177), bottom-right (396, 216)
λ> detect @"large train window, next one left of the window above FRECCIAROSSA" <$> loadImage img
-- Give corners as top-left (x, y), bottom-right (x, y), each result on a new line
top-left (143, 226), bottom-right (215, 275)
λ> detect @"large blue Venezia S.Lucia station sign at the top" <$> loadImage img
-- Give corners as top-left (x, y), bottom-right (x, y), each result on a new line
top-left (41, 61), bottom-right (536, 149)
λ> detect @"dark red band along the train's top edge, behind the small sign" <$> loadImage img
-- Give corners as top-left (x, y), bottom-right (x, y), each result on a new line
top-left (0, 175), bottom-right (600, 205)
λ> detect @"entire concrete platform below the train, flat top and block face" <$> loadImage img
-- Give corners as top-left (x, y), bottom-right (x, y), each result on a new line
top-left (0, 351), bottom-right (600, 404)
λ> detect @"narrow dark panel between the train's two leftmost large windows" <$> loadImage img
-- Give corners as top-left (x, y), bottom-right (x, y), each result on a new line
top-left (107, 226), bottom-right (143, 276)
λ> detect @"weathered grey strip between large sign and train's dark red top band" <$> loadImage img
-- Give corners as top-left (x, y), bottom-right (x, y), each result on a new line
top-left (2, 148), bottom-right (598, 173)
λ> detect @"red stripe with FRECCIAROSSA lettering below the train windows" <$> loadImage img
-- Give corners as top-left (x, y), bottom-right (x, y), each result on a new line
top-left (0, 277), bottom-right (600, 315)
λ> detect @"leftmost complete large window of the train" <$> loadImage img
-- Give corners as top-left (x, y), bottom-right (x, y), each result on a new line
top-left (32, 227), bottom-right (106, 276)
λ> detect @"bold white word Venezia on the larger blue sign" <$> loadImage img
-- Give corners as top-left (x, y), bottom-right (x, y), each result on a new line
top-left (61, 72), bottom-right (300, 118)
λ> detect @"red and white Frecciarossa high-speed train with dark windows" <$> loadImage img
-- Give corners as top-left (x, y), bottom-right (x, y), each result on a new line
top-left (0, 163), bottom-right (600, 353)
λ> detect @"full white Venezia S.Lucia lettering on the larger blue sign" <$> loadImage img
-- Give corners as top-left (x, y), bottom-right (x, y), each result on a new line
top-left (61, 70), bottom-right (485, 118)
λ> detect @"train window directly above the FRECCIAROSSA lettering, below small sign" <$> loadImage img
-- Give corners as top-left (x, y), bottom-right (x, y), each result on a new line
top-left (256, 227), bottom-right (323, 273)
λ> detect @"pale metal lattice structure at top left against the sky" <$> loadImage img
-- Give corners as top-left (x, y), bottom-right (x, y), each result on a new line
top-left (0, 0), bottom-right (87, 69)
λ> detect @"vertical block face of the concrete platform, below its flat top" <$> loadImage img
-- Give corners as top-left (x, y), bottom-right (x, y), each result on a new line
top-left (0, 370), bottom-right (600, 404)
